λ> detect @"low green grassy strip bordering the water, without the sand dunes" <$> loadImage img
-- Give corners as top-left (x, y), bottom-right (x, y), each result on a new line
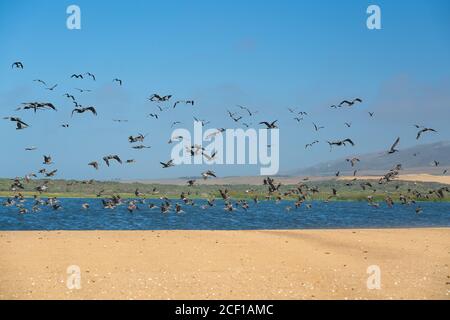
top-left (0, 179), bottom-right (450, 201)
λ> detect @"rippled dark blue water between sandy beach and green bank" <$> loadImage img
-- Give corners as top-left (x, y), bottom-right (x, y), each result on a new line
top-left (0, 199), bottom-right (450, 230)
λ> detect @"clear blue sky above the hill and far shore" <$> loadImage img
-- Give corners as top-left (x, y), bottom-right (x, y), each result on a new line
top-left (0, 0), bottom-right (450, 179)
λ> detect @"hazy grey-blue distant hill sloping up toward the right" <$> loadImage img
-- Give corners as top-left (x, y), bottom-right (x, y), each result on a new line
top-left (289, 141), bottom-right (450, 176)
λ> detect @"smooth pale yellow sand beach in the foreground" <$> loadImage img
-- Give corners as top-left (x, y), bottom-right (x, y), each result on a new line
top-left (0, 228), bottom-right (450, 299)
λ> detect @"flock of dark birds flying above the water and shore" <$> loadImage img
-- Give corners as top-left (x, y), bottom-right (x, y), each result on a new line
top-left (3, 61), bottom-right (449, 218)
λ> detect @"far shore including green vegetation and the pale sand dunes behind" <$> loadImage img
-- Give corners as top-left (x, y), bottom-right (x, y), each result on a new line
top-left (0, 174), bottom-right (450, 202)
